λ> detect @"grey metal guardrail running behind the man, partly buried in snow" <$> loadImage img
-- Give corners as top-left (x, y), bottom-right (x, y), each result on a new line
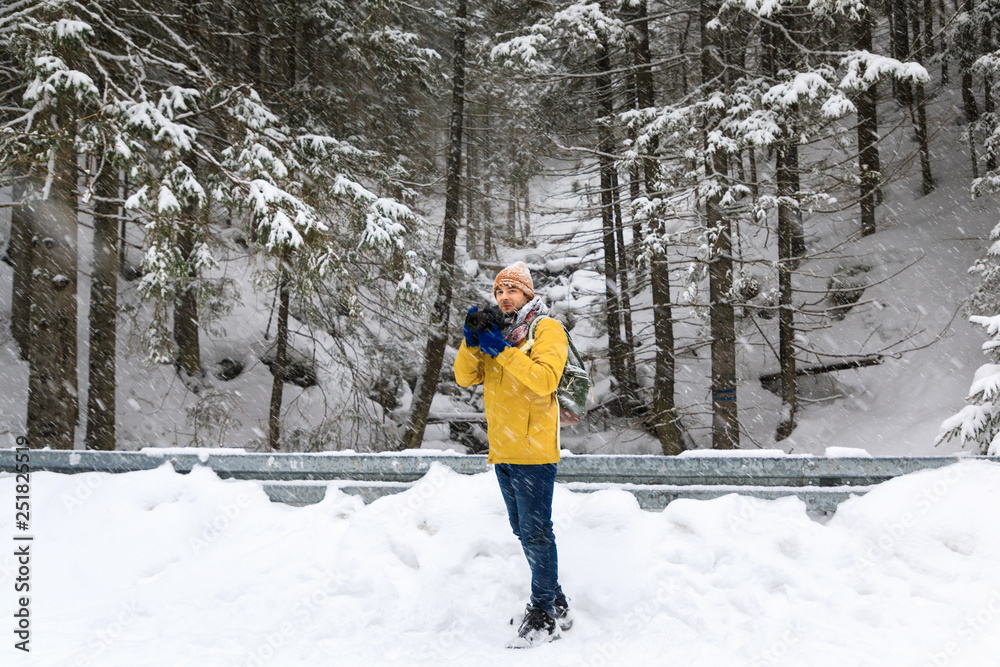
top-left (0, 448), bottom-right (984, 511)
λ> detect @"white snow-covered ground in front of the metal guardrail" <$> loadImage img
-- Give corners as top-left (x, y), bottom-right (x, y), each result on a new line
top-left (0, 460), bottom-right (1000, 667)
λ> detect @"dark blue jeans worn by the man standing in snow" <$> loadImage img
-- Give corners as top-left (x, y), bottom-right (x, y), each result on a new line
top-left (495, 463), bottom-right (562, 615)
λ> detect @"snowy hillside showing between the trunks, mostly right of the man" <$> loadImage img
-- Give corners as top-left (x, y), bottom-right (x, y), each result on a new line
top-left (440, 85), bottom-right (1000, 455)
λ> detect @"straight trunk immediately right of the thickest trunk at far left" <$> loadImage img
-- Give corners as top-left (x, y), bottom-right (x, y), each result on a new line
top-left (84, 157), bottom-right (119, 451)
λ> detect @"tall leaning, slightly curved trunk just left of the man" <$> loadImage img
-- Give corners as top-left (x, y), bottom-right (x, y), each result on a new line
top-left (402, 0), bottom-right (467, 449)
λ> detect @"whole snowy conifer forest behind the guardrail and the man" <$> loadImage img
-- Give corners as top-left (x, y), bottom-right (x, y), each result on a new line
top-left (0, 0), bottom-right (1000, 455)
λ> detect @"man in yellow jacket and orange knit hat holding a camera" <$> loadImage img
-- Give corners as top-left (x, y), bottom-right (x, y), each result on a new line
top-left (455, 262), bottom-right (572, 648)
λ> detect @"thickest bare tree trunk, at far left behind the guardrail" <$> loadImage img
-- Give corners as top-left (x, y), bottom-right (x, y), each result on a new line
top-left (27, 148), bottom-right (80, 449)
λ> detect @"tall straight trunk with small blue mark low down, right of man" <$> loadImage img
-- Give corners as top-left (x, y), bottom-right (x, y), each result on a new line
top-left (701, 0), bottom-right (740, 449)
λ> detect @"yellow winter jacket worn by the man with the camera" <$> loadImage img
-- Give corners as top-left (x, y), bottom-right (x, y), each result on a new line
top-left (455, 317), bottom-right (569, 465)
